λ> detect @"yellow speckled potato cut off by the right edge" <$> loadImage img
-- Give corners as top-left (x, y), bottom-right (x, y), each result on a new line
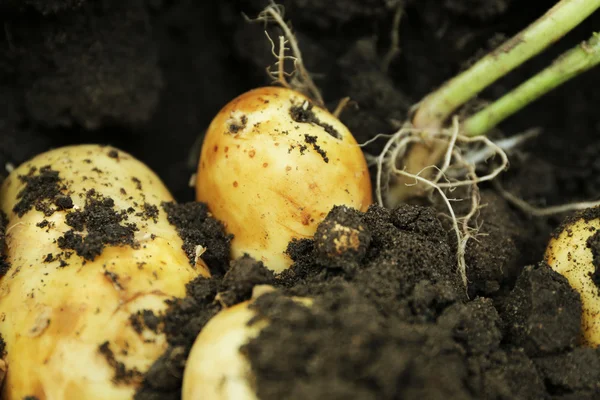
top-left (545, 215), bottom-right (600, 347)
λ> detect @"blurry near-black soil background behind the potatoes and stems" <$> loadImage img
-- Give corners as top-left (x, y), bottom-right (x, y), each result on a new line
top-left (0, 0), bottom-right (600, 202)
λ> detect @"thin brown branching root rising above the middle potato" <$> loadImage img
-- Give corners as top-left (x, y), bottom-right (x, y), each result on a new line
top-left (246, 2), bottom-right (325, 106)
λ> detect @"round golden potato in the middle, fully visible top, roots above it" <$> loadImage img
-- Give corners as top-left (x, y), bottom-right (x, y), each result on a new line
top-left (196, 87), bottom-right (372, 272)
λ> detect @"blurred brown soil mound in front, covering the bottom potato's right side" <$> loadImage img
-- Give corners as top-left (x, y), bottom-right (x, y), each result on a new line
top-left (241, 283), bottom-right (504, 400)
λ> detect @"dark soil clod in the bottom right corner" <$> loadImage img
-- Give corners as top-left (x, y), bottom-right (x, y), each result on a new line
top-left (535, 347), bottom-right (600, 399)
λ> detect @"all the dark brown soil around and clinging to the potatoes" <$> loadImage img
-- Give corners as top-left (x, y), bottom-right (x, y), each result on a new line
top-left (0, 0), bottom-right (600, 400)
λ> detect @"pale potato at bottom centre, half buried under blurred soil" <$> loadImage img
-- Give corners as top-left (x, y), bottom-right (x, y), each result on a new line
top-left (182, 290), bottom-right (312, 400)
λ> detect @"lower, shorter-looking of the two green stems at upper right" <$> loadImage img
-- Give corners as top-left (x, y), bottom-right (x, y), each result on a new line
top-left (463, 34), bottom-right (600, 136)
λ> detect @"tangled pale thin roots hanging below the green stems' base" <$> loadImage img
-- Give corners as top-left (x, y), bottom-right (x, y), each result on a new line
top-left (376, 117), bottom-right (509, 290)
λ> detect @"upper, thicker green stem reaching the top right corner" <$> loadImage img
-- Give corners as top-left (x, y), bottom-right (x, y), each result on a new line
top-left (413, 0), bottom-right (600, 128)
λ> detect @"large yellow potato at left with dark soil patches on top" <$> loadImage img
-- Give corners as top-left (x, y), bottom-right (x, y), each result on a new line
top-left (0, 145), bottom-right (209, 400)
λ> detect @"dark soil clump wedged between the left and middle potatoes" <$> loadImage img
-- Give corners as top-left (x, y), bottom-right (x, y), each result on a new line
top-left (162, 202), bottom-right (233, 276)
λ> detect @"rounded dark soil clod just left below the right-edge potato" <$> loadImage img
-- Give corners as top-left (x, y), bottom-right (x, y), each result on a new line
top-left (500, 264), bottom-right (581, 356)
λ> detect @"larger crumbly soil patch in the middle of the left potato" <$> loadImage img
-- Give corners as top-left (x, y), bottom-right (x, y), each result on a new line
top-left (57, 189), bottom-right (138, 261)
